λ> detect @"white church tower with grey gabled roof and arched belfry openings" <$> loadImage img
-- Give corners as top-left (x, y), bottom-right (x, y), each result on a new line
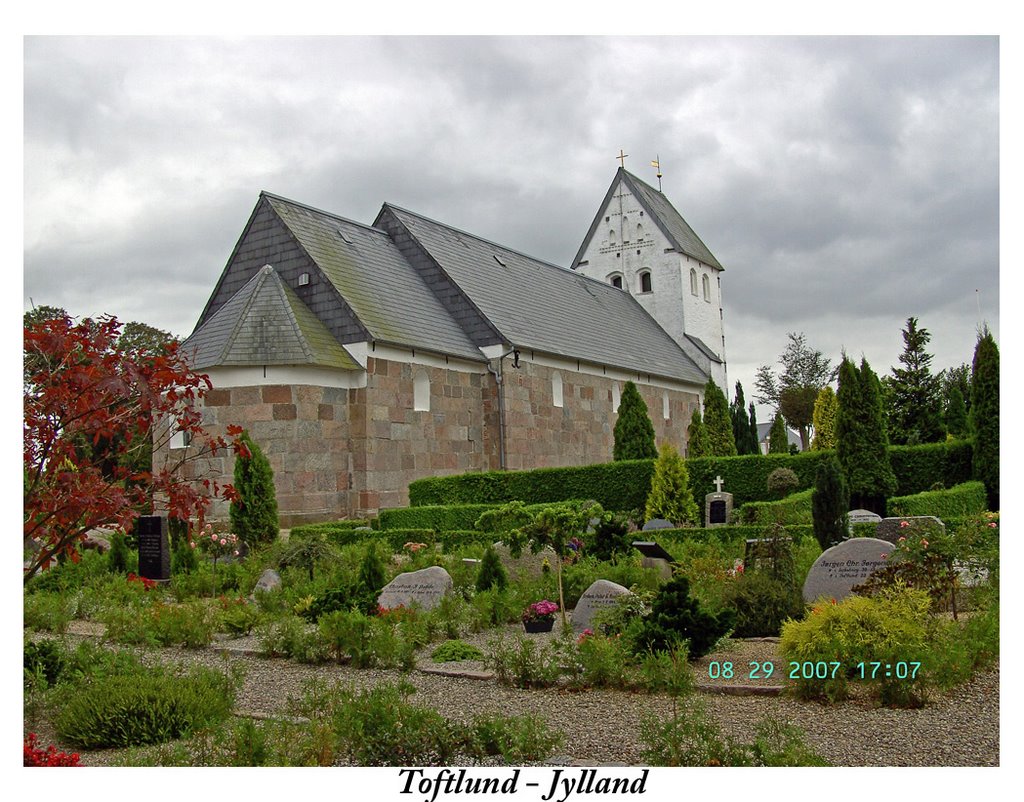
top-left (572, 167), bottom-right (729, 391)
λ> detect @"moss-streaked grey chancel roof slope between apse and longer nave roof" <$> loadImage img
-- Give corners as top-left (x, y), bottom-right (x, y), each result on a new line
top-left (264, 193), bottom-right (483, 362)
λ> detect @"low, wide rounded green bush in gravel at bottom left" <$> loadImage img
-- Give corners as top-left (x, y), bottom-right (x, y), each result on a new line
top-left (53, 668), bottom-right (236, 749)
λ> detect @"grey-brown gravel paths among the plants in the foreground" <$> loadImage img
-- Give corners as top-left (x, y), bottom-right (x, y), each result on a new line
top-left (34, 627), bottom-right (999, 766)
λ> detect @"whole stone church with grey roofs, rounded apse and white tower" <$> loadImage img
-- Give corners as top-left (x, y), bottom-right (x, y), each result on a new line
top-left (172, 168), bottom-right (726, 527)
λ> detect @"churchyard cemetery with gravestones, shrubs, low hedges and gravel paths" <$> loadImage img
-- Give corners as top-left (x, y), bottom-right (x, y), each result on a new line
top-left (25, 444), bottom-right (998, 765)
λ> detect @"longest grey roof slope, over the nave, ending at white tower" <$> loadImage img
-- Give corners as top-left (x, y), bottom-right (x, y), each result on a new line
top-left (387, 205), bottom-right (708, 384)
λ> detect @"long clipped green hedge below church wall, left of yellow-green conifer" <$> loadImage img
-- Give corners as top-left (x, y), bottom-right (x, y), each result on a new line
top-left (409, 460), bottom-right (654, 510)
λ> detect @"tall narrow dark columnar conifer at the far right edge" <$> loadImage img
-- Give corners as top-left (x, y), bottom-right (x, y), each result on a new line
top-left (971, 326), bottom-right (999, 512)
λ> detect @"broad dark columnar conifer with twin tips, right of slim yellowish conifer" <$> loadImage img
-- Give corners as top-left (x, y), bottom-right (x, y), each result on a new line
top-left (836, 356), bottom-right (896, 516)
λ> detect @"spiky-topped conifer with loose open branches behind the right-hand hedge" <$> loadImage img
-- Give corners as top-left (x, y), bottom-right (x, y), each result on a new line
top-left (886, 318), bottom-right (945, 446)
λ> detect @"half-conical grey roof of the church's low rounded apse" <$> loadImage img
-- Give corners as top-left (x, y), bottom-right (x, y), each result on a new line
top-left (182, 265), bottom-right (359, 370)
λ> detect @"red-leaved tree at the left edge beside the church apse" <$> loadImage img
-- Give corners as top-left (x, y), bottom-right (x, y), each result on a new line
top-left (25, 312), bottom-right (246, 581)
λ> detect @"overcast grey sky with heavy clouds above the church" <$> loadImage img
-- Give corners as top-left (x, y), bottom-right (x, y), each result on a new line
top-left (24, 37), bottom-right (999, 420)
